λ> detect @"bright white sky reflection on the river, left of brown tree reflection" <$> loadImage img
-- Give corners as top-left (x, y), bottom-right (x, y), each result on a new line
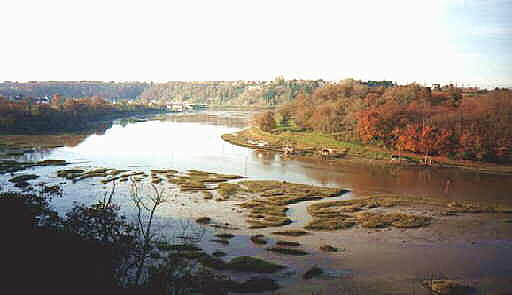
top-left (39, 121), bottom-right (340, 184)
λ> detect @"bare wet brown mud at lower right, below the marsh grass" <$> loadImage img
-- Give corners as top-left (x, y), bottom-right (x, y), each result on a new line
top-left (155, 173), bottom-right (512, 294)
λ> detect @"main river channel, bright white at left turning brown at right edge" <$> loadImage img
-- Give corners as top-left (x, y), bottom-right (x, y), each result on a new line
top-left (0, 111), bottom-right (512, 209)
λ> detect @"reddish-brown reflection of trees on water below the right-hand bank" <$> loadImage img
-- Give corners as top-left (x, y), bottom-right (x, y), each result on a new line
top-left (298, 158), bottom-right (512, 204)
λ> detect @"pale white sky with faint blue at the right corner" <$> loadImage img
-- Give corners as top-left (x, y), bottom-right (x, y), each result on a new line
top-left (0, 0), bottom-right (512, 87)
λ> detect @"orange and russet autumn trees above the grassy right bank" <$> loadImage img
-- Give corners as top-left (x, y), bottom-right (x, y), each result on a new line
top-left (268, 79), bottom-right (512, 163)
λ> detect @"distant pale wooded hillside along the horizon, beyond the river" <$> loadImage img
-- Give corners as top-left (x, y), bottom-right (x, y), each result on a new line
top-left (0, 78), bottom-right (326, 105)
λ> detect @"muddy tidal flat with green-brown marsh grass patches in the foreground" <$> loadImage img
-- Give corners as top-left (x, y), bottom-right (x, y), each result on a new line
top-left (10, 167), bottom-right (512, 294)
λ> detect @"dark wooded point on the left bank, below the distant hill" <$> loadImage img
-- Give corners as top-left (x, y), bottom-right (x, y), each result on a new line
top-left (0, 95), bottom-right (161, 134)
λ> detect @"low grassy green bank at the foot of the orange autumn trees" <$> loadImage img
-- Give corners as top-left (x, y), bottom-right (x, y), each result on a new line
top-left (222, 127), bottom-right (512, 175)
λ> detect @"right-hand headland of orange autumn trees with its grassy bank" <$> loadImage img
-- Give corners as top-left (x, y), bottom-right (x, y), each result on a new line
top-left (232, 79), bottom-right (512, 173)
